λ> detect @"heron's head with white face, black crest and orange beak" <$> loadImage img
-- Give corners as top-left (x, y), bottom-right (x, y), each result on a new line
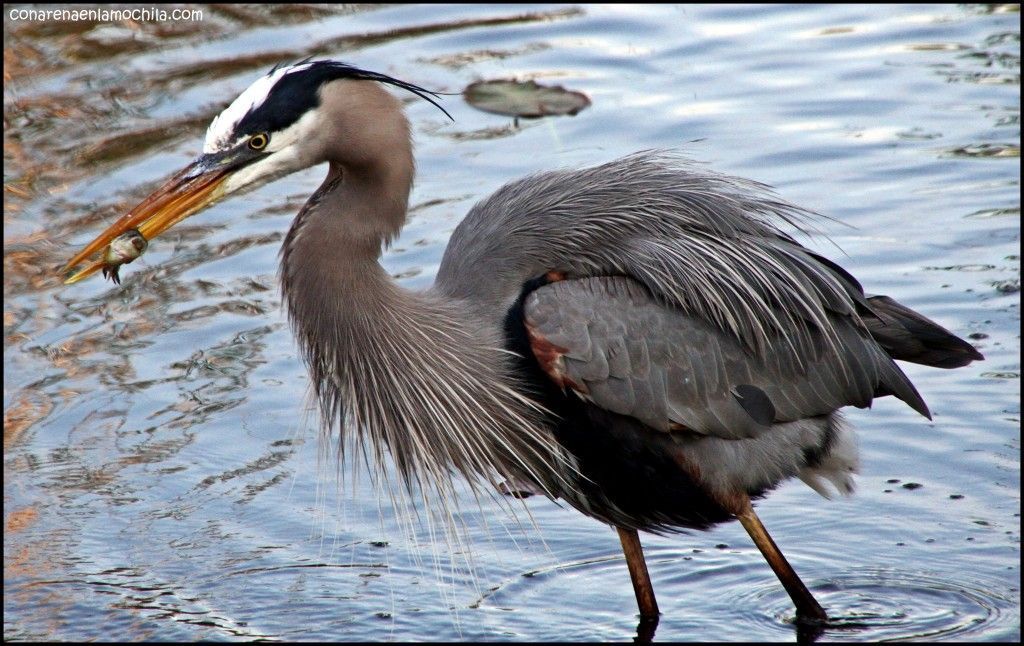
top-left (65, 60), bottom-right (447, 284)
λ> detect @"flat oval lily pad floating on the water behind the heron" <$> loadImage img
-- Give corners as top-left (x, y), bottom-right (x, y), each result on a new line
top-left (462, 80), bottom-right (590, 118)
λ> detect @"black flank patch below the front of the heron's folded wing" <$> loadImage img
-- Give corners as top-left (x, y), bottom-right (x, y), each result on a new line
top-left (505, 272), bottom-right (737, 532)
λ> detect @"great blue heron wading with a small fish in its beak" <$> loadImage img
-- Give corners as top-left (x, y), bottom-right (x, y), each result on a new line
top-left (68, 60), bottom-right (982, 638)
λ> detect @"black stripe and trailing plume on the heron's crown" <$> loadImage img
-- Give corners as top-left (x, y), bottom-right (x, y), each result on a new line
top-left (234, 60), bottom-right (454, 135)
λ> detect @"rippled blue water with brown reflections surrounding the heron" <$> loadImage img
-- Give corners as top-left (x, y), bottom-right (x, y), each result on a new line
top-left (4, 5), bottom-right (1020, 641)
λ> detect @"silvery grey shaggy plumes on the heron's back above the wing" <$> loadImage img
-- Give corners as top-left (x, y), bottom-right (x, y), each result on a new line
top-left (437, 152), bottom-right (854, 362)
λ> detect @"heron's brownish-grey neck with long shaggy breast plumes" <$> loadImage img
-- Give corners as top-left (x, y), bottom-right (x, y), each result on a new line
top-left (282, 160), bottom-right (565, 512)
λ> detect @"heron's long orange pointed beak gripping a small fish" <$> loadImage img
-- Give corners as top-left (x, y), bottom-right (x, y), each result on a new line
top-left (62, 156), bottom-right (233, 285)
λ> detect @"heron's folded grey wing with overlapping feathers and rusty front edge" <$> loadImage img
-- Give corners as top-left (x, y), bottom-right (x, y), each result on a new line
top-left (523, 276), bottom-right (928, 438)
